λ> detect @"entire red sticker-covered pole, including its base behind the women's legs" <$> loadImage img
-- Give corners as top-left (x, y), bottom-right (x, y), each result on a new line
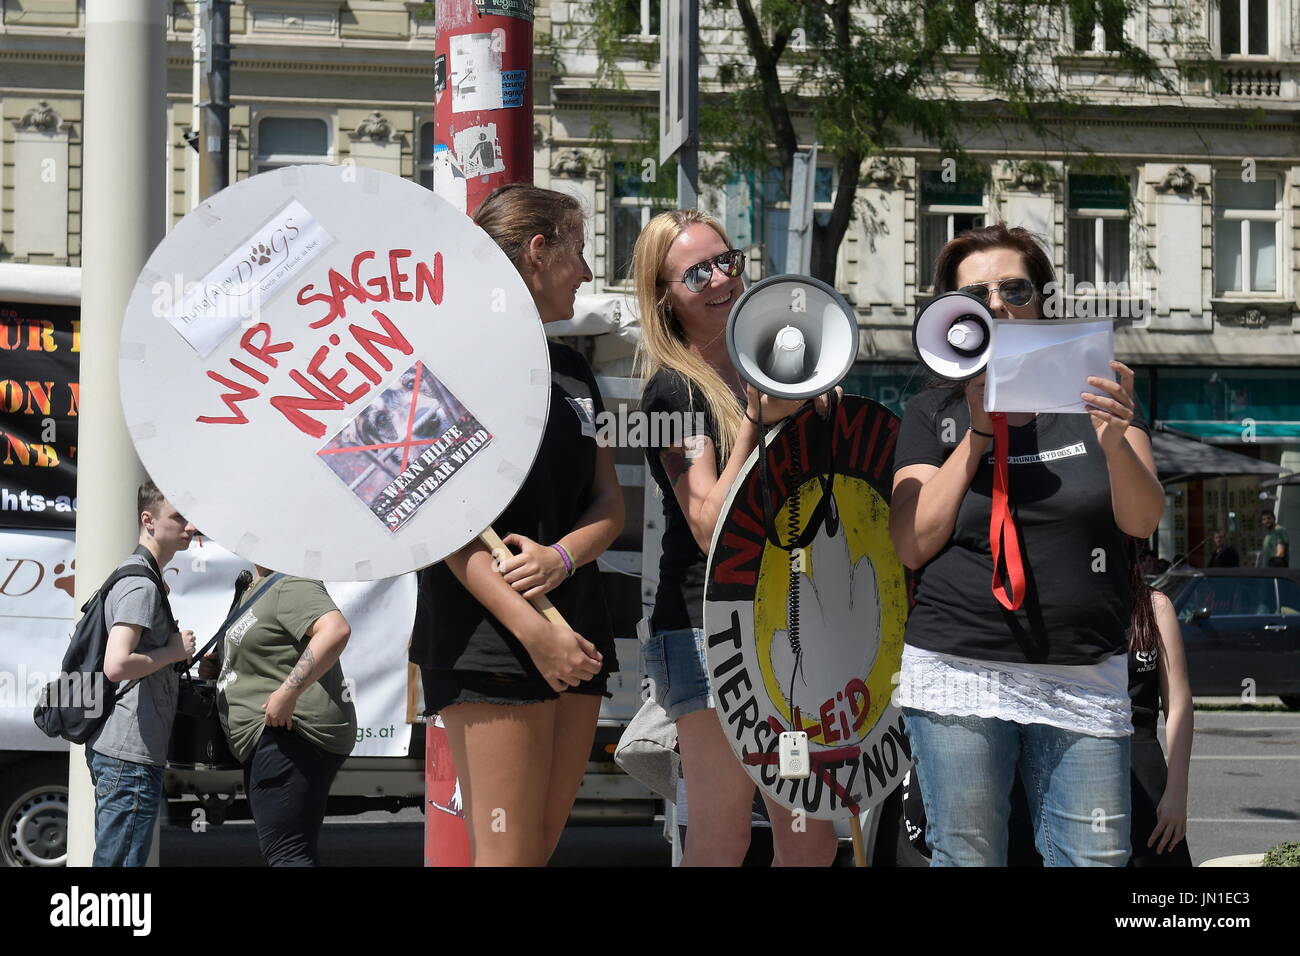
top-left (424, 0), bottom-right (533, 866)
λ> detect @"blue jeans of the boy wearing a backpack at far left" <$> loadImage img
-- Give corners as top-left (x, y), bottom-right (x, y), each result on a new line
top-left (86, 747), bottom-right (163, 866)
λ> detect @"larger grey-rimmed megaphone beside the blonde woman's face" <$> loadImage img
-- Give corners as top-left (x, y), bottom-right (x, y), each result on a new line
top-left (727, 276), bottom-right (858, 398)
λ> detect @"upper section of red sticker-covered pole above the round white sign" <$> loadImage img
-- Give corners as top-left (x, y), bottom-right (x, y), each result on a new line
top-left (433, 0), bottom-right (533, 215)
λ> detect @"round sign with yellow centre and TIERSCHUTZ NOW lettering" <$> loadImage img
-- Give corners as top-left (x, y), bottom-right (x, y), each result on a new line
top-left (705, 395), bottom-right (911, 819)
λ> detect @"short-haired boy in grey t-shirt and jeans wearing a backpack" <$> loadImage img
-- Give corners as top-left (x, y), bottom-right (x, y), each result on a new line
top-left (86, 481), bottom-right (196, 866)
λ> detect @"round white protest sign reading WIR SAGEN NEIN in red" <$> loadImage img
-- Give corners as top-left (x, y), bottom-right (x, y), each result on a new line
top-left (118, 165), bottom-right (550, 580)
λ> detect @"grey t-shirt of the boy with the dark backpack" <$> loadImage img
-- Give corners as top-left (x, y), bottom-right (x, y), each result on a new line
top-left (87, 554), bottom-right (179, 766)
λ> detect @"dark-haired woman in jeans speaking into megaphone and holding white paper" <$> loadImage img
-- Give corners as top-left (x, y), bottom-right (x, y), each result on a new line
top-left (891, 224), bottom-right (1164, 866)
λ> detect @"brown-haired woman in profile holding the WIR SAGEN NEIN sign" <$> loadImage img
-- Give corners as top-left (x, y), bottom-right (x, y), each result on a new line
top-left (411, 183), bottom-right (623, 866)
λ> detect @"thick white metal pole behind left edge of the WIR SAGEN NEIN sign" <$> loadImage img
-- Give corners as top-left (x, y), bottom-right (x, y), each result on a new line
top-left (68, 0), bottom-right (166, 866)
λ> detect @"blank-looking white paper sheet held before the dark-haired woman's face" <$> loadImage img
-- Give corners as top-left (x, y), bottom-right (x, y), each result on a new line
top-left (984, 319), bottom-right (1115, 412)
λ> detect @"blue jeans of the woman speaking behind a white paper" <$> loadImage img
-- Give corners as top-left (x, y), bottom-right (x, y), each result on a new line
top-left (904, 708), bottom-right (1130, 866)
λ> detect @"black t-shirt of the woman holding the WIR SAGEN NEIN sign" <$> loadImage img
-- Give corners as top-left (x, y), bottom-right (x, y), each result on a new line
top-left (410, 342), bottom-right (619, 679)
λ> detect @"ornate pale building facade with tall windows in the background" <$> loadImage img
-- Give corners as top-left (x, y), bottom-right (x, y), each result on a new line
top-left (0, 0), bottom-right (1300, 563)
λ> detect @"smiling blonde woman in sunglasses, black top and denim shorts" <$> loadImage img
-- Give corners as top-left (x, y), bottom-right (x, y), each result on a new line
top-left (632, 209), bottom-right (836, 866)
